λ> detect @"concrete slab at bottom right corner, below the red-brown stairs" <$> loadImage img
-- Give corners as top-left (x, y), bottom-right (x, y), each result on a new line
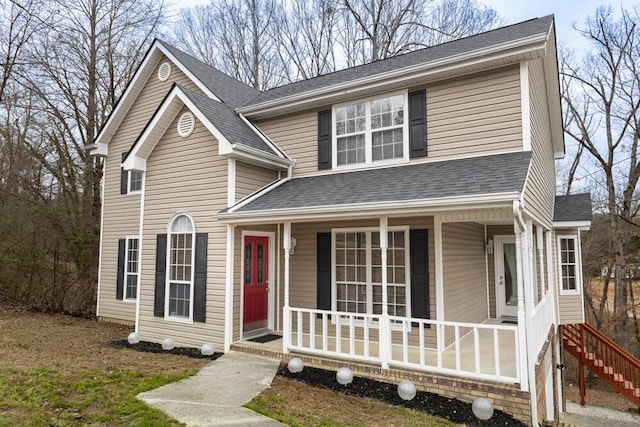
top-left (560, 402), bottom-right (640, 427)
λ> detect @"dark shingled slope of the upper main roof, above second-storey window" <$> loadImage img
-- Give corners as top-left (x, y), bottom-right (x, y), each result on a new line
top-left (241, 15), bottom-right (553, 107)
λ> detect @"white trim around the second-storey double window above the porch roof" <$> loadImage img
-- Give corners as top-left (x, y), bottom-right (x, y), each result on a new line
top-left (331, 89), bottom-right (409, 171)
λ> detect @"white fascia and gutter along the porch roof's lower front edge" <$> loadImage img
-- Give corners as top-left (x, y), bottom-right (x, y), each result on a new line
top-left (214, 192), bottom-right (520, 224)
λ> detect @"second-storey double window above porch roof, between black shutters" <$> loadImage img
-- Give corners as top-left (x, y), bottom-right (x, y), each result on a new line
top-left (333, 94), bottom-right (408, 167)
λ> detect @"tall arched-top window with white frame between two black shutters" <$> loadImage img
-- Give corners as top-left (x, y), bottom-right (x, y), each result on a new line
top-left (167, 215), bottom-right (195, 320)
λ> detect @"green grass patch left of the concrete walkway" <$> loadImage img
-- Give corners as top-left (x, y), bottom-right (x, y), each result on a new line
top-left (0, 368), bottom-right (194, 427)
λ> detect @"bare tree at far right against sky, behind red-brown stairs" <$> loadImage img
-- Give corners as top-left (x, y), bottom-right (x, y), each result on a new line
top-left (561, 7), bottom-right (640, 347)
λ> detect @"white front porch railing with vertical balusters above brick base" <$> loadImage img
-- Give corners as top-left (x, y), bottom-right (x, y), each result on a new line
top-left (283, 308), bottom-right (520, 383)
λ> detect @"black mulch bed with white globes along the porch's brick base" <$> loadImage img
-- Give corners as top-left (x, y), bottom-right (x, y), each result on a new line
top-left (278, 363), bottom-right (526, 427)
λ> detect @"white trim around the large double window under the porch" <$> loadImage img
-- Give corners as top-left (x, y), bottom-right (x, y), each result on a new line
top-left (331, 225), bottom-right (412, 330)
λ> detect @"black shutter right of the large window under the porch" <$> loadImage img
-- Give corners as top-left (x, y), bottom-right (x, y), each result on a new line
top-left (409, 230), bottom-right (429, 319)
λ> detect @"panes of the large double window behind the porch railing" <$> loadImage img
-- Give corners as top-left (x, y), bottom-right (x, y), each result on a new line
top-left (332, 229), bottom-right (409, 316)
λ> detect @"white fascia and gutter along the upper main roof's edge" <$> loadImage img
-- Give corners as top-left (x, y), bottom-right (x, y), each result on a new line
top-left (236, 33), bottom-right (548, 117)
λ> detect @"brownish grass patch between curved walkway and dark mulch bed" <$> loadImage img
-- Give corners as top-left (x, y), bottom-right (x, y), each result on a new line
top-left (245, 376), bottom-right (454, 427)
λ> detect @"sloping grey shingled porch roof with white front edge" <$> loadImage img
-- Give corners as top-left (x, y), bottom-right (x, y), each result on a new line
top-left (218, 152), bottom-right (531, 222)
